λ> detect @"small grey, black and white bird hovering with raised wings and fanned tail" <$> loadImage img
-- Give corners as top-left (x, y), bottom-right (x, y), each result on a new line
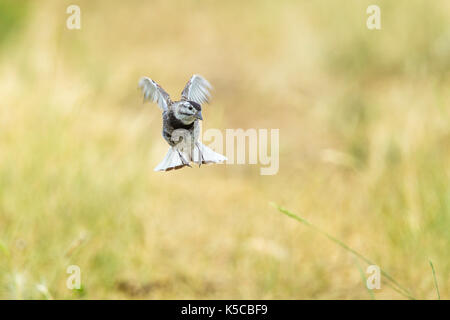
top-left (139, 74), bottom-right (227, 171)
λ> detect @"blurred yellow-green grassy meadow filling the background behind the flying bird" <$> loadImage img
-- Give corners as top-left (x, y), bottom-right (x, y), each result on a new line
top-left (0, 0), bottom-right (450, 299)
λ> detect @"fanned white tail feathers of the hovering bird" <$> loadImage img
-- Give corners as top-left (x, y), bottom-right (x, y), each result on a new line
top-left (154, 142), bottom-right (227, 171)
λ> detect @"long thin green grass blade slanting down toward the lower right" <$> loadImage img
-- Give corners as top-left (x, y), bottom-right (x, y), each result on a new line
top-left (270, 202), bottom-right (415, 300)
